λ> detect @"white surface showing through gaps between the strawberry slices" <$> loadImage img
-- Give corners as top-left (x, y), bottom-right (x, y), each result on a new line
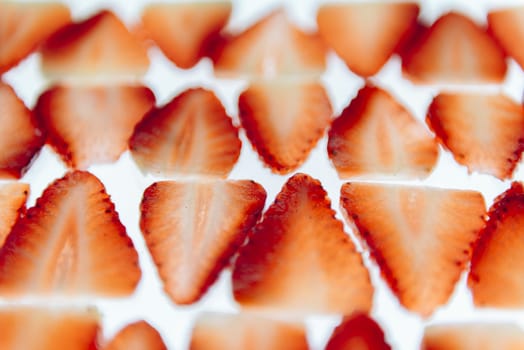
top-left (3, 0), bottom-right (524, 350)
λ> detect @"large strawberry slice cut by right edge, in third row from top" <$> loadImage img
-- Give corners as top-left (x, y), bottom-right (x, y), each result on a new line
top-left (468, 182), bottom-right (524, 308)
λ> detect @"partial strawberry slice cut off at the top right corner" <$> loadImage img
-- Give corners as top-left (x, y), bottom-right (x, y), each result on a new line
top-left (488, 6), bottom-right (524, 68)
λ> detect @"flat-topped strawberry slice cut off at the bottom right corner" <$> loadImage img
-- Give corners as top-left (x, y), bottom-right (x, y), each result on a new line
top-left (420, 322), bottom-right (524, 350)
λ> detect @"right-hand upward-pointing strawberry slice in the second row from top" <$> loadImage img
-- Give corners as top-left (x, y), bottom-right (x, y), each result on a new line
top-left (327, 85), bottom-right (438, 178)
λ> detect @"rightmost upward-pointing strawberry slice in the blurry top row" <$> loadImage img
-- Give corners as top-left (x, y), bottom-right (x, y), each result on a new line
top-left (402, 12), bottom-right (507, 84)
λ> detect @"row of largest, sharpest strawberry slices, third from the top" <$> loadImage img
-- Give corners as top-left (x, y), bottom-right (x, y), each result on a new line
top-left (0, 171), bottom-right (524, 316)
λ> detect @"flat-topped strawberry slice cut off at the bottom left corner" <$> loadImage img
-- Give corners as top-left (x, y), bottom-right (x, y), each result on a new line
top-left (0, 306), bottom-right (100, 350)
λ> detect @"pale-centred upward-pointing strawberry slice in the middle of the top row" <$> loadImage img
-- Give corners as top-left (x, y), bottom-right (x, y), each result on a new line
top-left (213, 10), bottom-right (327, 78)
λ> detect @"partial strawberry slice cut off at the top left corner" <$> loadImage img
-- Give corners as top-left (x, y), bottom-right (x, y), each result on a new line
top-left (0, 1), bottom-right (71, 73)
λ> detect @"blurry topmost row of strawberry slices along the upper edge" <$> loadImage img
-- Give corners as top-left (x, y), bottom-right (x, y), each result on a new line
top-left (0, 1), bottom-right (524, 83)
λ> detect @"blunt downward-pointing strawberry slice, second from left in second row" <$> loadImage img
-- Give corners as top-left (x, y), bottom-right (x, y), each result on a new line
top-left (35, 85), bottom-right (155, 169)
